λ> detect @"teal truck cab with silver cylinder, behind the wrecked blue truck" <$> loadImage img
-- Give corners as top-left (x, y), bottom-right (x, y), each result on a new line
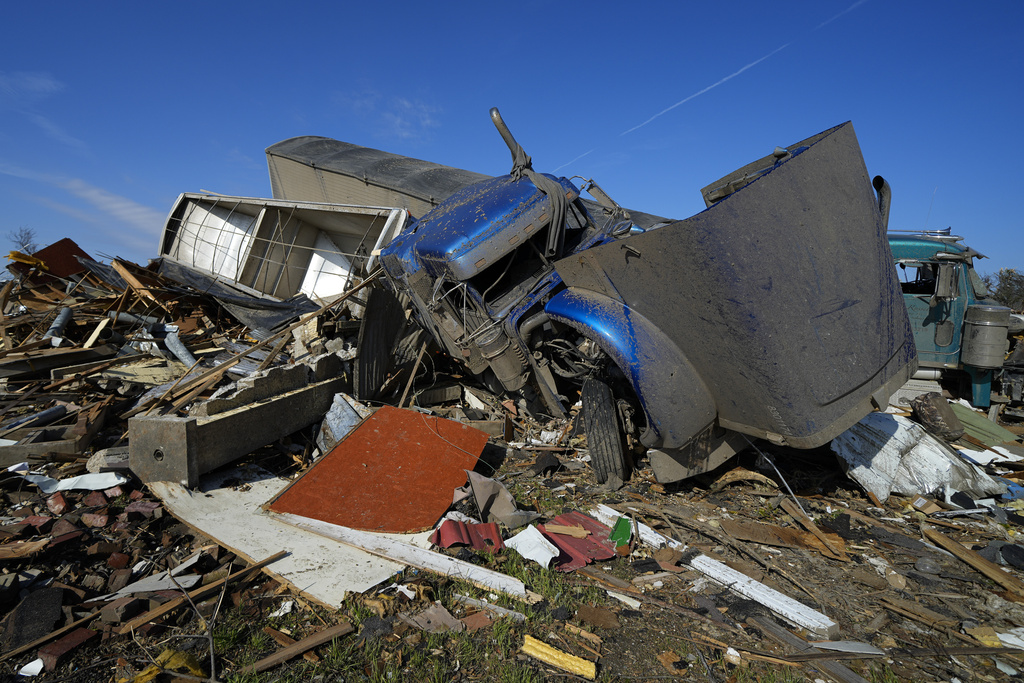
top-left (888, 229), bottom-right (1024, 408)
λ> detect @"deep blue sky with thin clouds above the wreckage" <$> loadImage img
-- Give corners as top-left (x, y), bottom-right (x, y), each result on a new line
top-left (0, 0), bottom-right (1024, 272)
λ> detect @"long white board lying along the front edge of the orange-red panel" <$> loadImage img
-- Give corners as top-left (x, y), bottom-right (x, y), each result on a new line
top-left (274, 513), bottom-right (527, 600)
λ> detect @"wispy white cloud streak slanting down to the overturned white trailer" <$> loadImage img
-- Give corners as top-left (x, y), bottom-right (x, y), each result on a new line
top-left (0, 162), bottom-right (165, 240)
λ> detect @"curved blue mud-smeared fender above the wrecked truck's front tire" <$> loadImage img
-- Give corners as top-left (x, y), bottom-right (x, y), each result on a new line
top-left (544, 287), bottom-right (717, 449)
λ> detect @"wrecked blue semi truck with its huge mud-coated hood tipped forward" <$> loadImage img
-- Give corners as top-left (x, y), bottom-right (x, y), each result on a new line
top-left (267, 111), bottom-right (915, 481)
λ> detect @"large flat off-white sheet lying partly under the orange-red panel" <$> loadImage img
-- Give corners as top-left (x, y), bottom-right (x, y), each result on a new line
top-left (150, 467), bottom-right (429, 607)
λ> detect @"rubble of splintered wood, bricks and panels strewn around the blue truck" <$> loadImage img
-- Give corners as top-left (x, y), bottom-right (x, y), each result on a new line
top-left (0, 114), bottom-right (1024, 683)
